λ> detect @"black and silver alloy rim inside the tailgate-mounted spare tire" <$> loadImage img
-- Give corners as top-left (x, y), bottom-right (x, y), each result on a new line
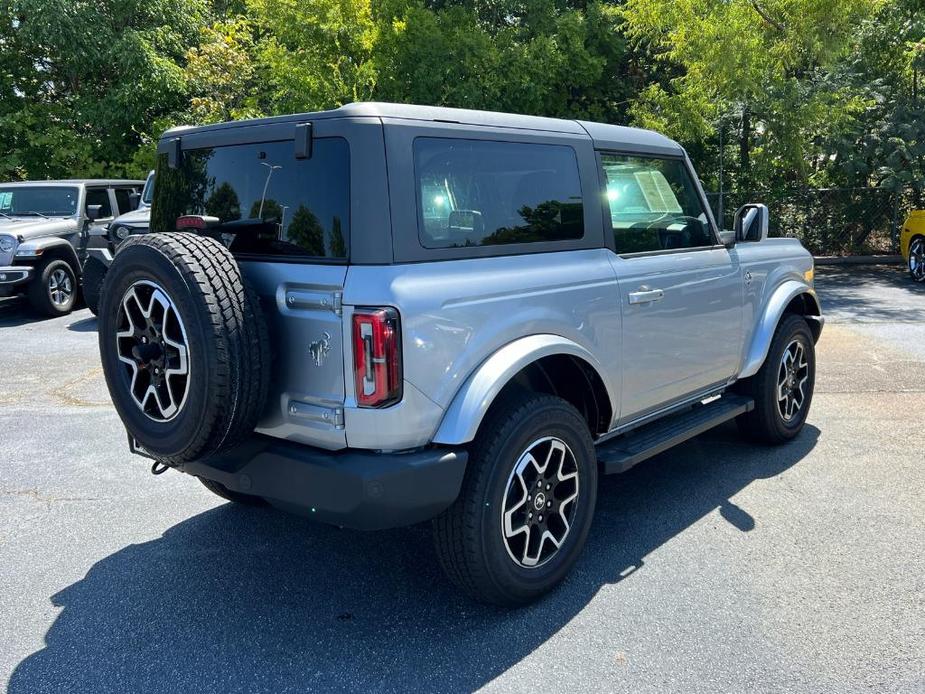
top-left (116, 280), bottom-right (190, 422)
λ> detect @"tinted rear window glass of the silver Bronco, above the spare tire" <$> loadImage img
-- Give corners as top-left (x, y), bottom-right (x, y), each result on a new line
top-left (151, 137), bottom-right (350, 260)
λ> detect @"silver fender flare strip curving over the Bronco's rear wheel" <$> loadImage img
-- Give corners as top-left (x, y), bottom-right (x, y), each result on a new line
top-left (432, 334), bottom-right (616, 445)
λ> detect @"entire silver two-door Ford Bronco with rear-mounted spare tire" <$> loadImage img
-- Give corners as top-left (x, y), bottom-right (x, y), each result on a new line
top-left (99, 103), bottom-right (823, 604)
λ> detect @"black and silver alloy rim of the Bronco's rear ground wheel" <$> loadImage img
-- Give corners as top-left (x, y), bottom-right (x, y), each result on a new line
top-left (501, 437), bottom-right (579, 568)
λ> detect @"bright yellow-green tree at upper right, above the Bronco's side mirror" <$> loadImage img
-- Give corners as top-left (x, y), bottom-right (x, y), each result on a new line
top-left (623, 0), bottom-right (883, 189)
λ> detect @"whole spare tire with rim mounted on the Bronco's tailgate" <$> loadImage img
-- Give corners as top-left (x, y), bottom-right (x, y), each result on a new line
top-left (98, 233), bottom-right (270, 465)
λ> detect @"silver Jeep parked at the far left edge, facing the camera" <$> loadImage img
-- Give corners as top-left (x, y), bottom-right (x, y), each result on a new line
top-left (0, 180), bottom-right (143, 316)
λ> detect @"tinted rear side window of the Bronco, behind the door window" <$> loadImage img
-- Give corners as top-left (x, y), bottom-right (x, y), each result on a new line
top-left (414, 137), bottom-right (584, 248)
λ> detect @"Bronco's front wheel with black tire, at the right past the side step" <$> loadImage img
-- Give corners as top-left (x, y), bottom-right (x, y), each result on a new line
top-left (736, 314), bottom-right (816, 444)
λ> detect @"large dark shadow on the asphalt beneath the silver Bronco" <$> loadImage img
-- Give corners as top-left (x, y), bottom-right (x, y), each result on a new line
top-left (9, 426), bottom-right (819, 694)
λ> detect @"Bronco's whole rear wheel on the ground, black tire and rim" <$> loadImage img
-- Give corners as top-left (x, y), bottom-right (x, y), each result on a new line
top-left (433, 393), bottom-right (597, 606)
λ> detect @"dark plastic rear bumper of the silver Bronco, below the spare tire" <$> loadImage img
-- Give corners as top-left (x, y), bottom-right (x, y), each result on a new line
top-left (173, 434), bottom-right (468, 530)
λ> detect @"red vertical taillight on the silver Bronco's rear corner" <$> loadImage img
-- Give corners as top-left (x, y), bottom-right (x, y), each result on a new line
top-left (353, 308), bottom-right (402, 407)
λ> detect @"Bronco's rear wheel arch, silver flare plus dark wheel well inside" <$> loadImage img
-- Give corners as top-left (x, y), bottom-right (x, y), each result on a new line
top-left (433, 335), bottom-right (616, 445)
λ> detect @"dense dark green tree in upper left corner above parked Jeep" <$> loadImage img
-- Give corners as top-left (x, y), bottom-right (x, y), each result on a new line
top-left (0, 0), bottom-right (208, 182)
